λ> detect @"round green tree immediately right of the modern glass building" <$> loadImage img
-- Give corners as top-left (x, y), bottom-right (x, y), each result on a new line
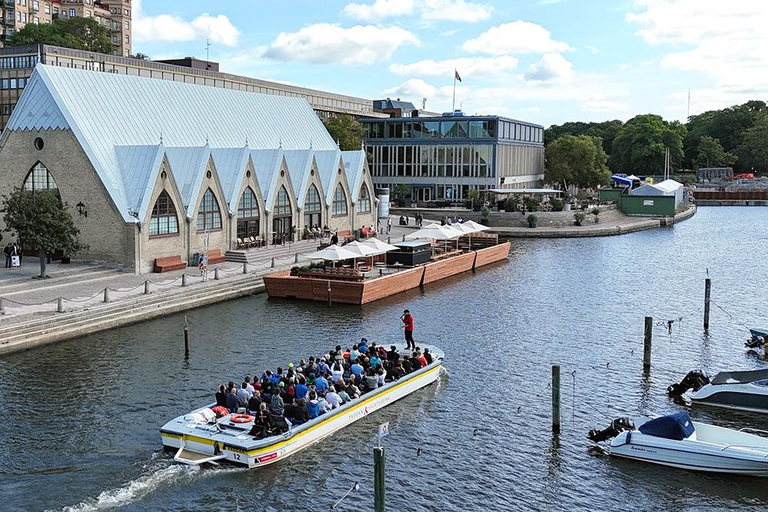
top-left (544, 135), bottom-right (611, 190)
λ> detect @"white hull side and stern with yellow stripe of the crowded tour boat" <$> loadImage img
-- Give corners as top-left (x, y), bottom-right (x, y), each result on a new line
top-left (161, 361), bottom-right (442, 468)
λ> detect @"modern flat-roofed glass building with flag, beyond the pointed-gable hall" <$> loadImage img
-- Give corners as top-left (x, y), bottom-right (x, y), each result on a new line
top-left (360, 113), bottom-right (544, 203)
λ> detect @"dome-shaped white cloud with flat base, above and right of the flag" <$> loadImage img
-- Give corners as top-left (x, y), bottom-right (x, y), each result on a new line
top-left (461, 20), bottom-right (573, 55)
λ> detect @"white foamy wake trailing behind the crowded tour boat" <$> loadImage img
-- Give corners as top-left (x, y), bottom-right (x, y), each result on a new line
top-left (54, 461), bottom-right (237, 512)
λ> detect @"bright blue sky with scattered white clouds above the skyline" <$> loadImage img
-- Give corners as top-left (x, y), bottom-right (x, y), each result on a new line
top-left (133, 0), bottom-right (768, 126)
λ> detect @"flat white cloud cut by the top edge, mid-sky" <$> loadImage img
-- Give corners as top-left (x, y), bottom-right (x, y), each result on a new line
top-left (342, 0), bottom-right (492, 23)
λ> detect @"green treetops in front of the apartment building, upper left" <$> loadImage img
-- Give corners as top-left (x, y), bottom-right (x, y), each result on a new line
top-left (8, 17), bottom-right (112, 54)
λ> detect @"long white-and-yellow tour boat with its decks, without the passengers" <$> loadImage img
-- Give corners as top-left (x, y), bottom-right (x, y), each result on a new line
top-left (160, 345), bottom-right (445, 468)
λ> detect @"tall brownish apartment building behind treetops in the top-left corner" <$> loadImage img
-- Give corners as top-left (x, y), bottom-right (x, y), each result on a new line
top-left (0, 0), bottom-right (132, 57)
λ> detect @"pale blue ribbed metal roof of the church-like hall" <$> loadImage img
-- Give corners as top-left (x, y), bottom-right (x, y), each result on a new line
top-left (6, 65), bottom-right (338, 222)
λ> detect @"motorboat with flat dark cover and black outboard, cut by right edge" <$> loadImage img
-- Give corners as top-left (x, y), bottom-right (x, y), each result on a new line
top-left (667, 369), bottom-right (768, 413)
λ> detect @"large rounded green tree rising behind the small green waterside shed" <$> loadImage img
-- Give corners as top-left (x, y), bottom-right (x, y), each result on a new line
top-left (609, 114), bottom-right (686, 174)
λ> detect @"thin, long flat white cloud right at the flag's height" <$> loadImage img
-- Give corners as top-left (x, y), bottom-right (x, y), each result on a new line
top-left (389, 55), bottom-right (518, 80)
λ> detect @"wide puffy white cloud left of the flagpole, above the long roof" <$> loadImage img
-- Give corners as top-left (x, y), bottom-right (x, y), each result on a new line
top-left (262, 23), bottom-right (420, 65)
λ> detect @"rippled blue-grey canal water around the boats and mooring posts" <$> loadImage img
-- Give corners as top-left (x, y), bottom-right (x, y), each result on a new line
top-left (0, 208), bottom-right (768, 511)
